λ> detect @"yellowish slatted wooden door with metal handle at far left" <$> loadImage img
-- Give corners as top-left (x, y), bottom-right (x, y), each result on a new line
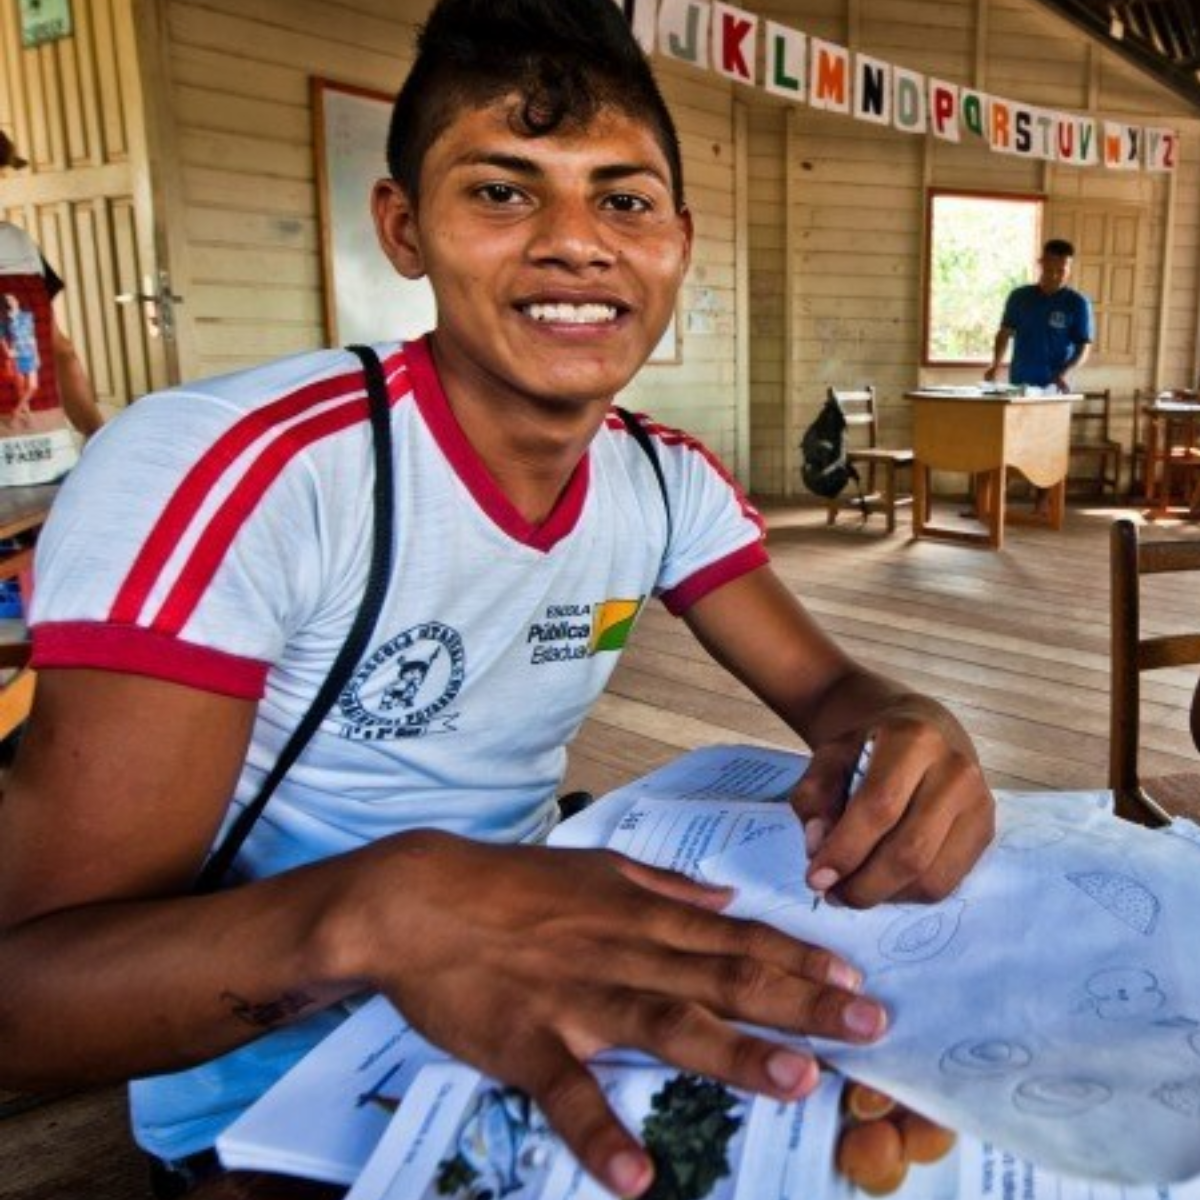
top-left (0, 0), bottom-right (178, 412)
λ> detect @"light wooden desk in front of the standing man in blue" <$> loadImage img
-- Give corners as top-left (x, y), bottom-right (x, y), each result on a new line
top-left (905, 389), bottom-right (1081, 550)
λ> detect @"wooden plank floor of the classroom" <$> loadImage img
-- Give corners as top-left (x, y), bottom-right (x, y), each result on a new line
top-left (0, 494), bottom-right (1200, 1200)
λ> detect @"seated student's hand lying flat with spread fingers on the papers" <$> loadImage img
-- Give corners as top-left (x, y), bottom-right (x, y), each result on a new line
top-left (344, 830), bottom-right (887, 1195)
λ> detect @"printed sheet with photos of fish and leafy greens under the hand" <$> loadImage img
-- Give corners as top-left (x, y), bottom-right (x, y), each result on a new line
top-left (333, 1063), bottom-right (1200, 1200)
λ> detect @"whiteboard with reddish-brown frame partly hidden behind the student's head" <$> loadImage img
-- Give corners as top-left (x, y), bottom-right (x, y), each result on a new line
top-left (312, 76), bottom-right (434, 346)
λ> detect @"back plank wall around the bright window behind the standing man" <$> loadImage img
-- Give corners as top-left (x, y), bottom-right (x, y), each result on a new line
top-left (751, 0), bottom-right (1200, 496)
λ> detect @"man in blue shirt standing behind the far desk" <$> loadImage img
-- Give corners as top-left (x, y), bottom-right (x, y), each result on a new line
top-left (983, 238), bottom-right (1096, 391)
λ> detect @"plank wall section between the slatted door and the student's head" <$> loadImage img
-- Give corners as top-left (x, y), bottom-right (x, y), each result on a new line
top-left (164, 0), bottom-right (412, 378)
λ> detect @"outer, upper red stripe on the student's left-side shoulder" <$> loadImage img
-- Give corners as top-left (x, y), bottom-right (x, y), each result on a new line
top-left (109, 350), bottom-right (404, 625)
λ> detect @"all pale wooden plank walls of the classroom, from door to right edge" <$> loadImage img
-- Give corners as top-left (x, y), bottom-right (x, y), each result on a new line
top-left (152, 0), bottom-right (1200, 494)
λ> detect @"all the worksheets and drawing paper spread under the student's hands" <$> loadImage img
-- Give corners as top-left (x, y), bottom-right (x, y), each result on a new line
top-left (218, 746), bottom-right (1200, 1200)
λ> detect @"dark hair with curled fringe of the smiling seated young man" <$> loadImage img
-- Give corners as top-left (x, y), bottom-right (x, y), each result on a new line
top-left (388, 0), bottom-right (684, 209)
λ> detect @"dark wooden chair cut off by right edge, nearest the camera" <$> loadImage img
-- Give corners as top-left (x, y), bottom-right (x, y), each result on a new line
top-left (1109, 517), bottom-right (1200, 824)
